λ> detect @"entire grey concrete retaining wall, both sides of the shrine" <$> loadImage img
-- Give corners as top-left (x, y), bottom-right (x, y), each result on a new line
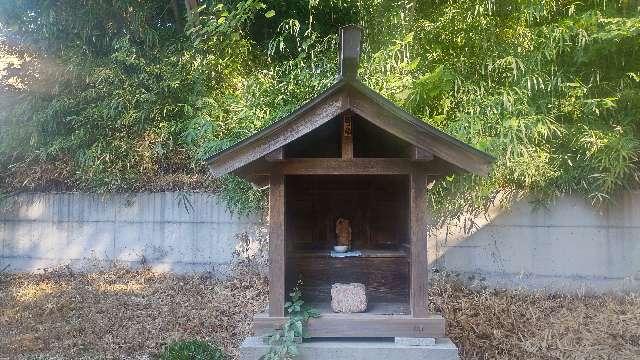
top-left (0, 192), bottom-right (640, 291)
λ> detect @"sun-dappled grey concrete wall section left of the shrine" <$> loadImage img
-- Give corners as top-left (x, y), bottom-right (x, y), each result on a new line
top-left (0, 192), bottom-right (260, 272)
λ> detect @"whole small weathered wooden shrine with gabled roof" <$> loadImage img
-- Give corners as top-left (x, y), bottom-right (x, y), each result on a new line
top-left (208, 26), bottom-right (493, 338)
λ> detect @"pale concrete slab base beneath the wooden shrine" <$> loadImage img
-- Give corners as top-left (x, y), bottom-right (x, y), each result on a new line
top-left (240, 337), bottom-right (460, 360)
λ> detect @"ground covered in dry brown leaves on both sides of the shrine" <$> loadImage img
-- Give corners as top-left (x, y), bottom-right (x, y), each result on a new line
top-left (0, 267), bottom-right (640, 360)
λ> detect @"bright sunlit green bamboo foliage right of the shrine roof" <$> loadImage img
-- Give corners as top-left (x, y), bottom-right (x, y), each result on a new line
top-left (356, 1), bottom-right (640, 219)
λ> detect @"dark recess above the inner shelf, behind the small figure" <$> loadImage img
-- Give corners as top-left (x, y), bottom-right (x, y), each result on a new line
top-left (285, 175), bottom-right (409, 252)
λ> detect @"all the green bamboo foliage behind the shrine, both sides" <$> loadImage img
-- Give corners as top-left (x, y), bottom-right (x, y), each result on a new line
top-left (0, 0), bottom-right (640, 219)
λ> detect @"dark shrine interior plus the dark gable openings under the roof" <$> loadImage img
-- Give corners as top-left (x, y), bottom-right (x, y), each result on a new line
top-left (285, 115), bottom-right (410, 314)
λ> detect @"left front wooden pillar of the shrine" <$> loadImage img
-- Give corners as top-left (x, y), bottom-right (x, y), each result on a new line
top-left (269, 166), bottom-right (286, 317)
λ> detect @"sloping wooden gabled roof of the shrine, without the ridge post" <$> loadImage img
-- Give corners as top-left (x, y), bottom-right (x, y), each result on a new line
top-left (206, 78), bottom-right (494, 176)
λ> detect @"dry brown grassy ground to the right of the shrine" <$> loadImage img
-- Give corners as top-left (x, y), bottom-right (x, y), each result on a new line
top-left (431, 277), bottom-right (640, 360)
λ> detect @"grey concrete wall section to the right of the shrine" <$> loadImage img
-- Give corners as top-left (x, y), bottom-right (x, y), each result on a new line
top-left (429, 192), bottom-right (640, 291)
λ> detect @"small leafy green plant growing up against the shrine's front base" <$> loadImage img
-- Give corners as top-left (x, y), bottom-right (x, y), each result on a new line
top-left (260, 282), bottom-right (320, 360)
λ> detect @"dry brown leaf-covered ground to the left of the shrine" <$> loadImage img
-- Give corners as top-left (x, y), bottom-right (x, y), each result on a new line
top-left (0, 267), bottom-right (267, 359)
